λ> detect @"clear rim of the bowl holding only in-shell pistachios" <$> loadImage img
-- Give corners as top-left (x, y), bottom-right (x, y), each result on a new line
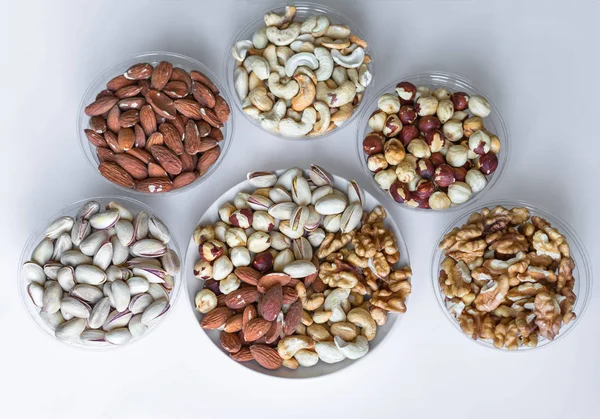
top-left (17, 195), bottom-right (185, 352)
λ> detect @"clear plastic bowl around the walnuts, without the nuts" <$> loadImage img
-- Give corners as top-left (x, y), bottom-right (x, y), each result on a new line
top-left (431, 200), bottom-right (592, 352)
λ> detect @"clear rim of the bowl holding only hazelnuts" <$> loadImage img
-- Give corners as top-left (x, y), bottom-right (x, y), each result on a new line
top-left (356, 70), bottom-right (511, 214)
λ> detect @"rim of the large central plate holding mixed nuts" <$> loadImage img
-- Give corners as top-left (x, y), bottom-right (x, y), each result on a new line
top-left (183, 166), bottom-right (414, 381)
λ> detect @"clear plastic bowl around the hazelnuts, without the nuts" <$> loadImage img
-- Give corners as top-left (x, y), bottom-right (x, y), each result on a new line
top-left (356, 72), bottom-right (510, 213)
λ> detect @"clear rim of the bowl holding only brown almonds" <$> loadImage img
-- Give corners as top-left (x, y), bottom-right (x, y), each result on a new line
top-left (75, 51), bottom-right (235, 197)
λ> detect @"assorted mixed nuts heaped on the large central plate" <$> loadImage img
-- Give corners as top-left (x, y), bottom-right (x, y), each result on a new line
top-left (193, 165), bottom-right (411, 369)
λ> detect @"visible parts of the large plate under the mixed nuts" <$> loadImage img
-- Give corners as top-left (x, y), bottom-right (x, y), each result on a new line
top-left (184, 170), bottom-right (410, 378)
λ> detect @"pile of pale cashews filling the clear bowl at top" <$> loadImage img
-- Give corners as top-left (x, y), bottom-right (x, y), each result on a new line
top-left (232, 6), bottom-right (372, 137)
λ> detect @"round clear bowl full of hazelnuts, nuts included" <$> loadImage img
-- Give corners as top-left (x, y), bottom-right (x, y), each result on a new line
top-left (357, 73), bottom-right (508, 211)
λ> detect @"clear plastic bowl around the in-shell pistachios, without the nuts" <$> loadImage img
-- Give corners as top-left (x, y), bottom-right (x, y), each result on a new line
top-left (17, 196), bottom-right (184, 351)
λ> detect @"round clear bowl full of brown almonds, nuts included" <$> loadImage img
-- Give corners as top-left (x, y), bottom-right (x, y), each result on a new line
top-left (77, 52), bottom-right (233, 194)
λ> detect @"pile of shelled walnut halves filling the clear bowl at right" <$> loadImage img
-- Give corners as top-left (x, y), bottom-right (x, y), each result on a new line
top-left (439, 206), bottom-right (576, 350)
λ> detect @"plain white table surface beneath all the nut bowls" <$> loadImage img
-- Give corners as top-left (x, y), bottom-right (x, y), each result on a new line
top-left (0, 0), bottom-right (600, 419)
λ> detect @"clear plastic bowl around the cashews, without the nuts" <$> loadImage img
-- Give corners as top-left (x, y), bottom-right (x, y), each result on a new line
top-left (223, 2), bottom-right (375, 141)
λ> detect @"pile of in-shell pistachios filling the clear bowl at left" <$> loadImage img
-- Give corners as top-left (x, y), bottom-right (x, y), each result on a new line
top-left (23, 201), bottom-right (180, 345)
